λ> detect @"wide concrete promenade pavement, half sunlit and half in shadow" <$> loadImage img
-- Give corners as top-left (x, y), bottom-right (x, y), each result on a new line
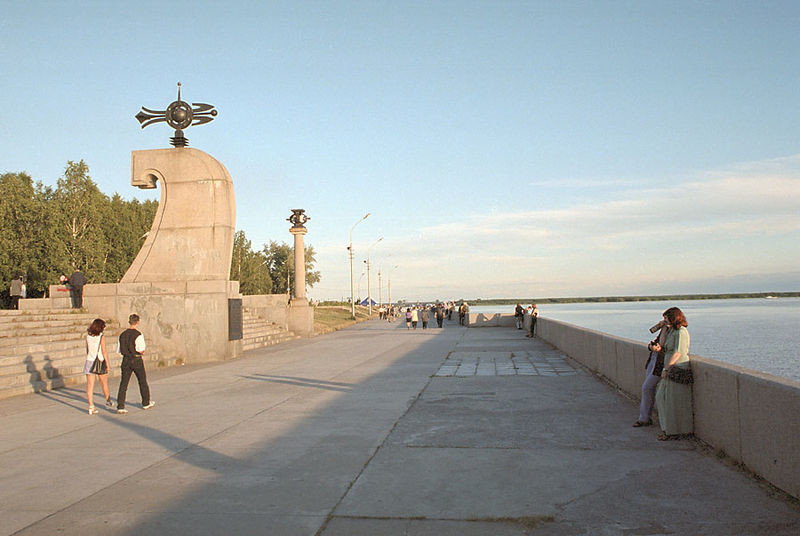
top-left (0, 320), bottom-right (800, 536)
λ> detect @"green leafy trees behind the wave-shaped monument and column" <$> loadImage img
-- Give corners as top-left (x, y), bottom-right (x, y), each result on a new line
top-left (0, 160), bottom-right (320, 308)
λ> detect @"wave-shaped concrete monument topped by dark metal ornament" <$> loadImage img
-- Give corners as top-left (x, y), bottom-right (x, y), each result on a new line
top-left (85, 84), bottom-right (242, 362)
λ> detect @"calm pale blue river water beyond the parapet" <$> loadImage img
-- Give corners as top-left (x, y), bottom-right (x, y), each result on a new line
top-left (470, 298), bottom-right (800, 381)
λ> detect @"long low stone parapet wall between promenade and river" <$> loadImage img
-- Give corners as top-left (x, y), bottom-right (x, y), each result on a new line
top-left (532, 315), bottom-right (800, 498)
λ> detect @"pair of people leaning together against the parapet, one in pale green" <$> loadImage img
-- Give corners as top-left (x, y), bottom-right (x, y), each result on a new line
top-left (633, 307), bottom-right (694, 441)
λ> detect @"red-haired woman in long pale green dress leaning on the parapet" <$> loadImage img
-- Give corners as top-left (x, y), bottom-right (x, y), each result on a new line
top-left (656, 307), bottom-right (694, 441)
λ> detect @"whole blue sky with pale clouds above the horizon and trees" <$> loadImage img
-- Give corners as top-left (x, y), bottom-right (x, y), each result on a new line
top-left (0, 0), bottom-right (800, 301)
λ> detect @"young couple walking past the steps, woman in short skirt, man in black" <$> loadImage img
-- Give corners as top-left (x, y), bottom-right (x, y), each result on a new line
top-left (83, 314), bottom-right (156, 415)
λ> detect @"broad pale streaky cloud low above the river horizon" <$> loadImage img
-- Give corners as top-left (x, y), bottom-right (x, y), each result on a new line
top-left (312, 155), bottom-right (800, 298)
